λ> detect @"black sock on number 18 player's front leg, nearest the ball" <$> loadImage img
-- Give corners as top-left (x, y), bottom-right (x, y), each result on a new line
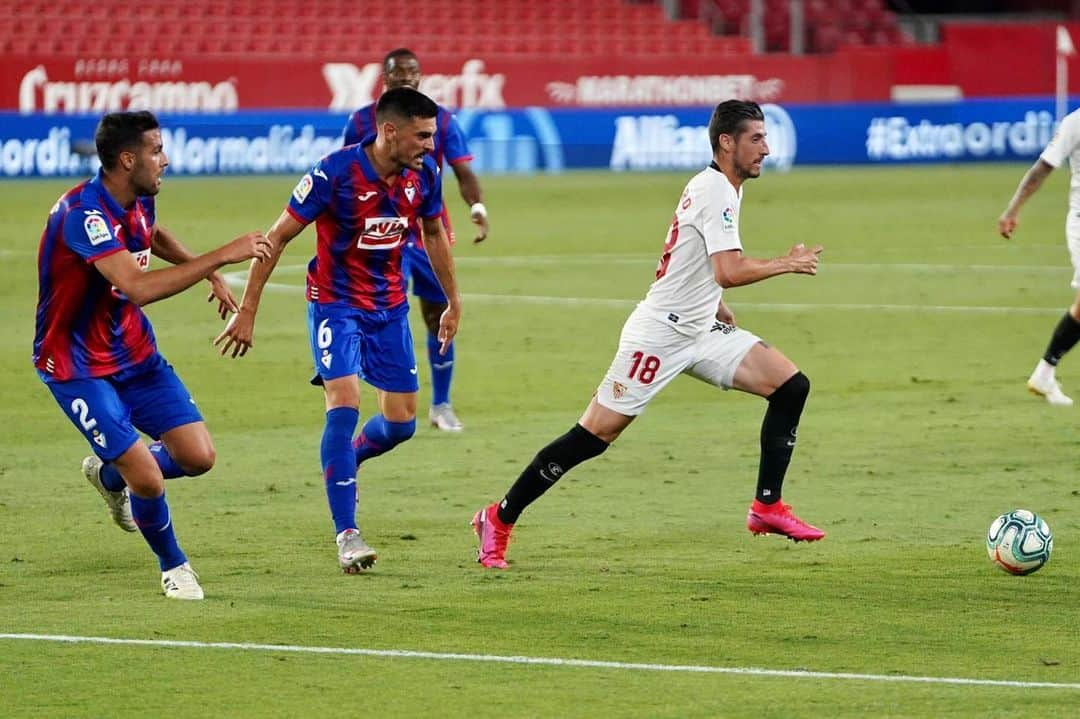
top-left (755, 372), bottom-right (810, 504)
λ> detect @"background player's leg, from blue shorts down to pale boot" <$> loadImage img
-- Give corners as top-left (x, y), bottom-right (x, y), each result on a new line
top-left (404, 240), bottom-right (464, 432)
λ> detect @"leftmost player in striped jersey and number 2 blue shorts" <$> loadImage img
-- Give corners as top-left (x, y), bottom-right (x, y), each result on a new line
top-left (33, 112), bottom-right (269, 599)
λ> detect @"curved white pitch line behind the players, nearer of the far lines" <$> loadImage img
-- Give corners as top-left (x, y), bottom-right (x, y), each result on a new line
top-left (225, 264), bottom-right (1063, 315)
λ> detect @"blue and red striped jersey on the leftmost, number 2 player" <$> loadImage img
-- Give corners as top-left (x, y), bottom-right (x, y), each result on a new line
top-left (33, 173), bottom-right (157, 381)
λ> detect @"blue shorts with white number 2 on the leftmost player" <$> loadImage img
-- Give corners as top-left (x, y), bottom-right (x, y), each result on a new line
top-left (38, 353), bottom-right (203, 462)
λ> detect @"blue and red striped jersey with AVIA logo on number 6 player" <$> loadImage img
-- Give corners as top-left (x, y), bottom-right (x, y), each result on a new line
top-left (286, 137), bottom-right (443, 310)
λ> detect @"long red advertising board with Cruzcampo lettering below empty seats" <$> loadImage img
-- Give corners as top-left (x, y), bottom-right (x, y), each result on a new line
top-left (0, 51), bottom-right (892, 113)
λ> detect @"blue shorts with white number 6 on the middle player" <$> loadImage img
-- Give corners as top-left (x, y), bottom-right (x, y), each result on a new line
top-left (308, 302), bottom-right (420, 392)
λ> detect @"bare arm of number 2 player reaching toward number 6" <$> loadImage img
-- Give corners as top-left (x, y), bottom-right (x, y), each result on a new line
top-left (94, 232), bottom-right (270, 306)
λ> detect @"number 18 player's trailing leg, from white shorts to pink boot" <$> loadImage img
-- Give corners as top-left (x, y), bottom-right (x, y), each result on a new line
top-left (472, 313), bottom-right (691, 569)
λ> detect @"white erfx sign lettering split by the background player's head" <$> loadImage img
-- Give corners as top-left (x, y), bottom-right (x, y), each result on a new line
top-left (323, 58), bottom-right (507, 112)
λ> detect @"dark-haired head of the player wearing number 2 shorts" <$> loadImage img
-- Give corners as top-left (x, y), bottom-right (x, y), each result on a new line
top-left (94, 110), bottom-right (168, 195)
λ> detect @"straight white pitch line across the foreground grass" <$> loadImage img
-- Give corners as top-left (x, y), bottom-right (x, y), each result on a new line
top-left (0, 634), bottom-right (1080, 691)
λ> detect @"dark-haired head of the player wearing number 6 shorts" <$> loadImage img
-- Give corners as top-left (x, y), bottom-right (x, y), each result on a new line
top-left (375, 87), bottom-right (438, 169)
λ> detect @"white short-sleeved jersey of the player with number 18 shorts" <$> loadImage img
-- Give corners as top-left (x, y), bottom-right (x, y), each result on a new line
top-left (639, 163), bottom-right (742, 333)
